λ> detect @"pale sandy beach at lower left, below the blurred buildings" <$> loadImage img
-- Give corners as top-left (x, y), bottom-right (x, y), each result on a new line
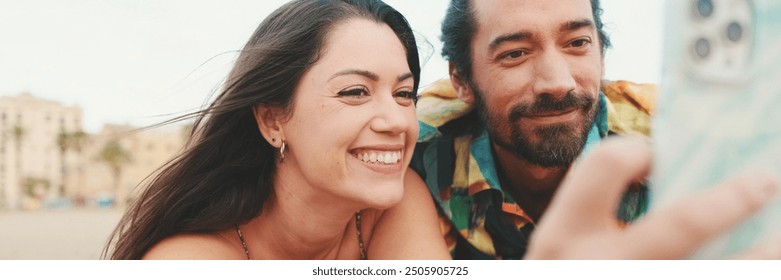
top-left (0, 209), bottom-right (122, 260)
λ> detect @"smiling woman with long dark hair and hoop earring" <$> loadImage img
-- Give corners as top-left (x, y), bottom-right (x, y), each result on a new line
top-left (105, 0), bottom-right (448, 259)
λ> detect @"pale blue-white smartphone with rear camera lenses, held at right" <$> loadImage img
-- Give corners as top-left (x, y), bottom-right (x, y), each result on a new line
top-left (651, 0), bottom-right (781, 259)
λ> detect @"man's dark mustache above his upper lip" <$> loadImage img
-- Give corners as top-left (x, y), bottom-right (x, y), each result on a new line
top-left (509, 91), bottom-right (594, 122)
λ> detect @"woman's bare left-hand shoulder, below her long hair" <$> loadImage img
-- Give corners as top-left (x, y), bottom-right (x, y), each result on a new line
top-left (143, 230), bottom-right (247, 260)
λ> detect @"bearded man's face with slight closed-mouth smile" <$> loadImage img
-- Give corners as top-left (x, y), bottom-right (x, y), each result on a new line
top-left (467, 0), bottom-right (602, 167)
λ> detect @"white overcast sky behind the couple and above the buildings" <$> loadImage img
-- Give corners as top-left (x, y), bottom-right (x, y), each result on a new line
top-left (0, 0), bottom-right (663, 132)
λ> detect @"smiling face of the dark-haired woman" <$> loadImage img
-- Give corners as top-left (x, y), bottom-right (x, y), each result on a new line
top-left (280, 18), bottom-right (418, 208)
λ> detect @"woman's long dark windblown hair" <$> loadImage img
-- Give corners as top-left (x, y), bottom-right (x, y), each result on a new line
top-left (102, 0), bottom-right (420, 259)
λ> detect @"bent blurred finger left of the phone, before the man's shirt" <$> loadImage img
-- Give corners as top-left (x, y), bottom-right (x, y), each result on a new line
top-left (542, 137), bottom-right (651, 232)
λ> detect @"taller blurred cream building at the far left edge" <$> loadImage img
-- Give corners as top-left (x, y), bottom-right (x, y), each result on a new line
top-left (0, 93), bottom-right (82, 209)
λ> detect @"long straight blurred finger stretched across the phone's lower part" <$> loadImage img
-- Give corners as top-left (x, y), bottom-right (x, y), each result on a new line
top-left (625, 172), bottom-right (777, 259)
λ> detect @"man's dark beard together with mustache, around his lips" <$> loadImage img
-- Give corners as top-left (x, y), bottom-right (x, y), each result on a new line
top-left (471, 85), bottom-right (597, 167)
